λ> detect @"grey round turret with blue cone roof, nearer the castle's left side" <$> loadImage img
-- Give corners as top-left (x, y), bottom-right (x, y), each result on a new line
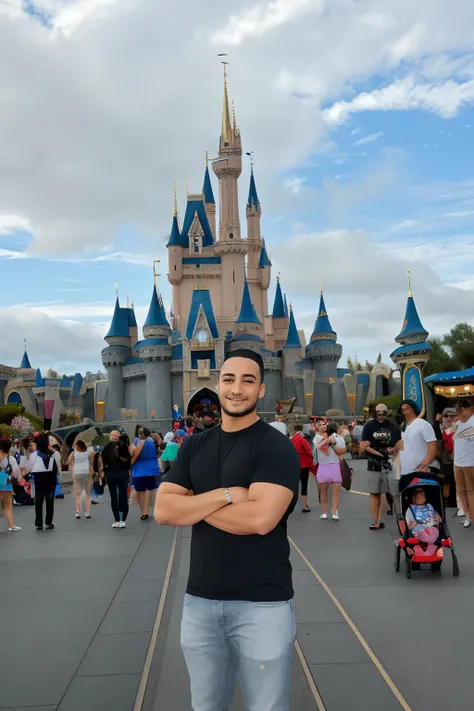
top-left (135, 284), bottom-right (172, 420)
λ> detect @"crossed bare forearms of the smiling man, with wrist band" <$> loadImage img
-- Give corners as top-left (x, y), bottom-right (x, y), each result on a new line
top-left (155, 482), bottom-right (293, 536)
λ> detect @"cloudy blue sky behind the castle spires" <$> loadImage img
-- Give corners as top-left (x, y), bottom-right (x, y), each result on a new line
top-left (0, 0), bottom-right (474, 373)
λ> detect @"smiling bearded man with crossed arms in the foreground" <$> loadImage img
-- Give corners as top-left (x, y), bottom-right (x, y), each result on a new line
top-left (155, 349), bottom-right (300, 711)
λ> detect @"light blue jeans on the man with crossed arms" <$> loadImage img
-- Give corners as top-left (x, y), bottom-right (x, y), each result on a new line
top-left (181, 594), bottom-right (296, 711)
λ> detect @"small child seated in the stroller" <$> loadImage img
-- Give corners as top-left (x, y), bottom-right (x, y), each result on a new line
top-left (405, 486), bottom-right (443, 558)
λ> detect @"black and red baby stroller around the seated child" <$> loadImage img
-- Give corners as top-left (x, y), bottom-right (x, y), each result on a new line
top-left (394, 472), bottom-right (459, 578)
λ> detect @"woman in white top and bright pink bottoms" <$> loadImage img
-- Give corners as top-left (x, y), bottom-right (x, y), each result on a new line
top-left (313, 423), bottom-right (346, 521)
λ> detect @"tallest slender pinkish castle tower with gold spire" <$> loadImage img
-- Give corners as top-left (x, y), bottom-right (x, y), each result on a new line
top-left (212, 65), bottom-right (247, 332)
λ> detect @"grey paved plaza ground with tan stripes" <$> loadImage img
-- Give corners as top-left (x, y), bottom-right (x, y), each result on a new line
top-left (0, 462), bottom-right (474, 711)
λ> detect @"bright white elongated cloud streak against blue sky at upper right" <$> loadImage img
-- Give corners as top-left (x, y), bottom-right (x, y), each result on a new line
top-left (324, 77), bottom-right (474, 125)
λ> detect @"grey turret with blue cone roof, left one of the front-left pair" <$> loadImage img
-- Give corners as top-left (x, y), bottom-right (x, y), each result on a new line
top-left (102, 296), bottom-right (132, 421)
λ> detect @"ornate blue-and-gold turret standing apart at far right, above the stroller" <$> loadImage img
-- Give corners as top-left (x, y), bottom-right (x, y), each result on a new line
top-left (390, 272), bottom-right (432, 417)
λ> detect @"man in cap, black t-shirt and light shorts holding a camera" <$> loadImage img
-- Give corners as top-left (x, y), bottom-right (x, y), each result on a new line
top-left (359, 403), bottom-right (402, 531)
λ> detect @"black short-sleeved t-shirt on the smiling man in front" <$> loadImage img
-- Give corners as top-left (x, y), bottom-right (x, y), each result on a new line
top-left (164, 420), bottom-right (300, 602)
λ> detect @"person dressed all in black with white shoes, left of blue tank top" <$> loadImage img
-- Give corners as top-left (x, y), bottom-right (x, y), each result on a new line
top-left (101, 430), bottom-right (132, 528)
